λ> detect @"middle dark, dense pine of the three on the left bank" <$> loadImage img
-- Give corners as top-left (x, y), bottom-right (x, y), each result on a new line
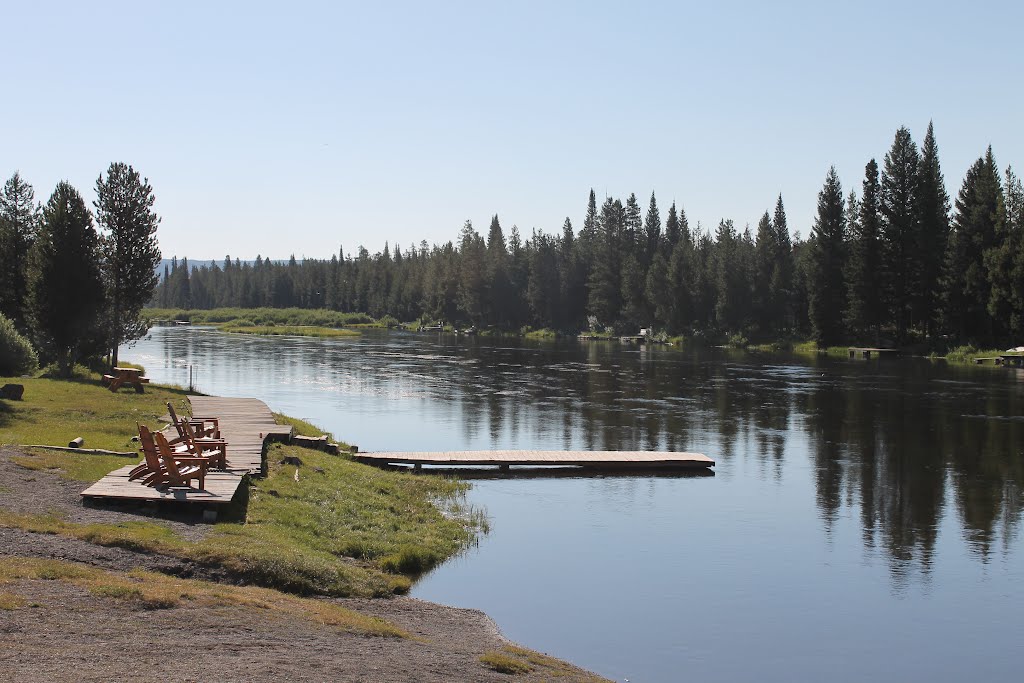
top-left (29, 181), bottom-right (104, 377)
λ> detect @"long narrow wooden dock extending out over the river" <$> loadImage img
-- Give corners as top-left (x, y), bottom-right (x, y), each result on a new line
top-left (353, 451), bottom-right (715, 470)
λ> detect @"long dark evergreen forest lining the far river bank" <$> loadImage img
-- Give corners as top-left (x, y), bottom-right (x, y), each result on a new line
top-left (154, 124), bottom-right (1024, 345)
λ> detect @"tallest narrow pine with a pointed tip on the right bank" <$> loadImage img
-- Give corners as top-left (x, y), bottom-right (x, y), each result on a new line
top-left (914, 121), bottom-right (949, 337)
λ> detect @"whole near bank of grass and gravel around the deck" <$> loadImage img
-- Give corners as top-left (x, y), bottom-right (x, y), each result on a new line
top-left (0, 380), bottom-right (601, 681)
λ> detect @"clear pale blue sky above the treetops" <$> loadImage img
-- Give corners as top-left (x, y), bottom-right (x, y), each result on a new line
top-left (0, 0), bottom-right (1024, 259)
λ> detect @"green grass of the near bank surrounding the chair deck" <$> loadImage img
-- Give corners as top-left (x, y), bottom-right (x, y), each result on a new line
top-left (0, 370), bottom-right (485, 596)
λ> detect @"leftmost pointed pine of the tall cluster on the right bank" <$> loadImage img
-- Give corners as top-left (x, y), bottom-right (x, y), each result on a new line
top-left (808, 166), bottom-right (846, 346)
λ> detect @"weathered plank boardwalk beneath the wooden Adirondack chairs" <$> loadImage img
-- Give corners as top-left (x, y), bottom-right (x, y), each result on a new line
top-left (82, 396), bottom-right (292, 505)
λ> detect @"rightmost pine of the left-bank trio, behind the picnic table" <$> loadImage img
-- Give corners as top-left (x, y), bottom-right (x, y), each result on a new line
top-left (93, 163), bottom-right (161, 366)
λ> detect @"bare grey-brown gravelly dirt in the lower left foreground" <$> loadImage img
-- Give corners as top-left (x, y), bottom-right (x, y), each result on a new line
top-left (0, 446), bottom-right (600, 683)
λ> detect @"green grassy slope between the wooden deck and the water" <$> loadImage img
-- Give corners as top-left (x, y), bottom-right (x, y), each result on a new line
top-left (202, 444), bottom-right (484, 595)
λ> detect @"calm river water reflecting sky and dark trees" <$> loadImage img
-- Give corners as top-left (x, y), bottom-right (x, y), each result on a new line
top-left (123, 328), bottom-right (1024, 683)
